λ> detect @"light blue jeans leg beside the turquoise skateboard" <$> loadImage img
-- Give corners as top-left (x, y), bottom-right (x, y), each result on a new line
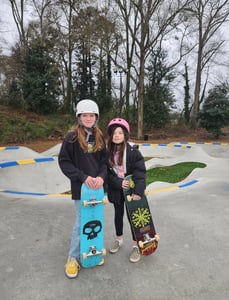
top-left (69, 200), bottom-right (80, 258)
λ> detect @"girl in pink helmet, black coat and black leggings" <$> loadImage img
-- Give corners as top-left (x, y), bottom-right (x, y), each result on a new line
top-left (107, 118), bottom-right (146, 262)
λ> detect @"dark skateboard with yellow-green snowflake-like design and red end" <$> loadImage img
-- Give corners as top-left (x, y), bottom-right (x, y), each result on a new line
top-left (123, 175), bottom-right (160, 255)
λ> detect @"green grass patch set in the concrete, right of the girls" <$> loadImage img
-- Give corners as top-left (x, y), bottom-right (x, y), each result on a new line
top-left (146, 162), bottom-right (206, 185)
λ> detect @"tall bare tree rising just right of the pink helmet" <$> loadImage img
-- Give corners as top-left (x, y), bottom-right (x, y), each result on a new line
top-left (115, 0), bottom-right (191, 138)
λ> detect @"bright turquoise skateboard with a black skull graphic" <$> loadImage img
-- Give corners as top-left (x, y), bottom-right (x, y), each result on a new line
top-left (80, 183), bottom-right (106, 268)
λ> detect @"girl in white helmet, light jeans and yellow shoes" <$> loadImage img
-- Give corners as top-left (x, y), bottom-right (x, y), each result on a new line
top-left (58, 99), bottom-right (107, 278)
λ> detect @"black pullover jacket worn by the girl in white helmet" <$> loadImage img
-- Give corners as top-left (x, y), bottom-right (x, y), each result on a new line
top-left (58, 132), bottom-right (107, 200)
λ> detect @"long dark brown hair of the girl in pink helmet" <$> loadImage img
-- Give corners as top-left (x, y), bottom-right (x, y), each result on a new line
top-left (107, 125), bottom-right (129, 167)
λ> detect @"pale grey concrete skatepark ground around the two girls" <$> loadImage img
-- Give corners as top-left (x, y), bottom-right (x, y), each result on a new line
top-left (0, 143), bottom-right (229, 300)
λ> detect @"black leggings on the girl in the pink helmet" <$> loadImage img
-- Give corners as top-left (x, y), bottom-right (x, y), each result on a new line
top-left (114, 194), bottom-right (136, 241)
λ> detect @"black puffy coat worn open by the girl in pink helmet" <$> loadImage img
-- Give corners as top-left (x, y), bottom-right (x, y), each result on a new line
top-left (107, 143), bottom-right (146, 204)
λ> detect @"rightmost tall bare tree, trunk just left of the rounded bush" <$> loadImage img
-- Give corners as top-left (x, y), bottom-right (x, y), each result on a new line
top-left (185, 0), bottom-right (229, 129)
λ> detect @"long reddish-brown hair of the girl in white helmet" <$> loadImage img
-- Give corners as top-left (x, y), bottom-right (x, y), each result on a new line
top-left (70, 124), bottom-right (105, 152)
